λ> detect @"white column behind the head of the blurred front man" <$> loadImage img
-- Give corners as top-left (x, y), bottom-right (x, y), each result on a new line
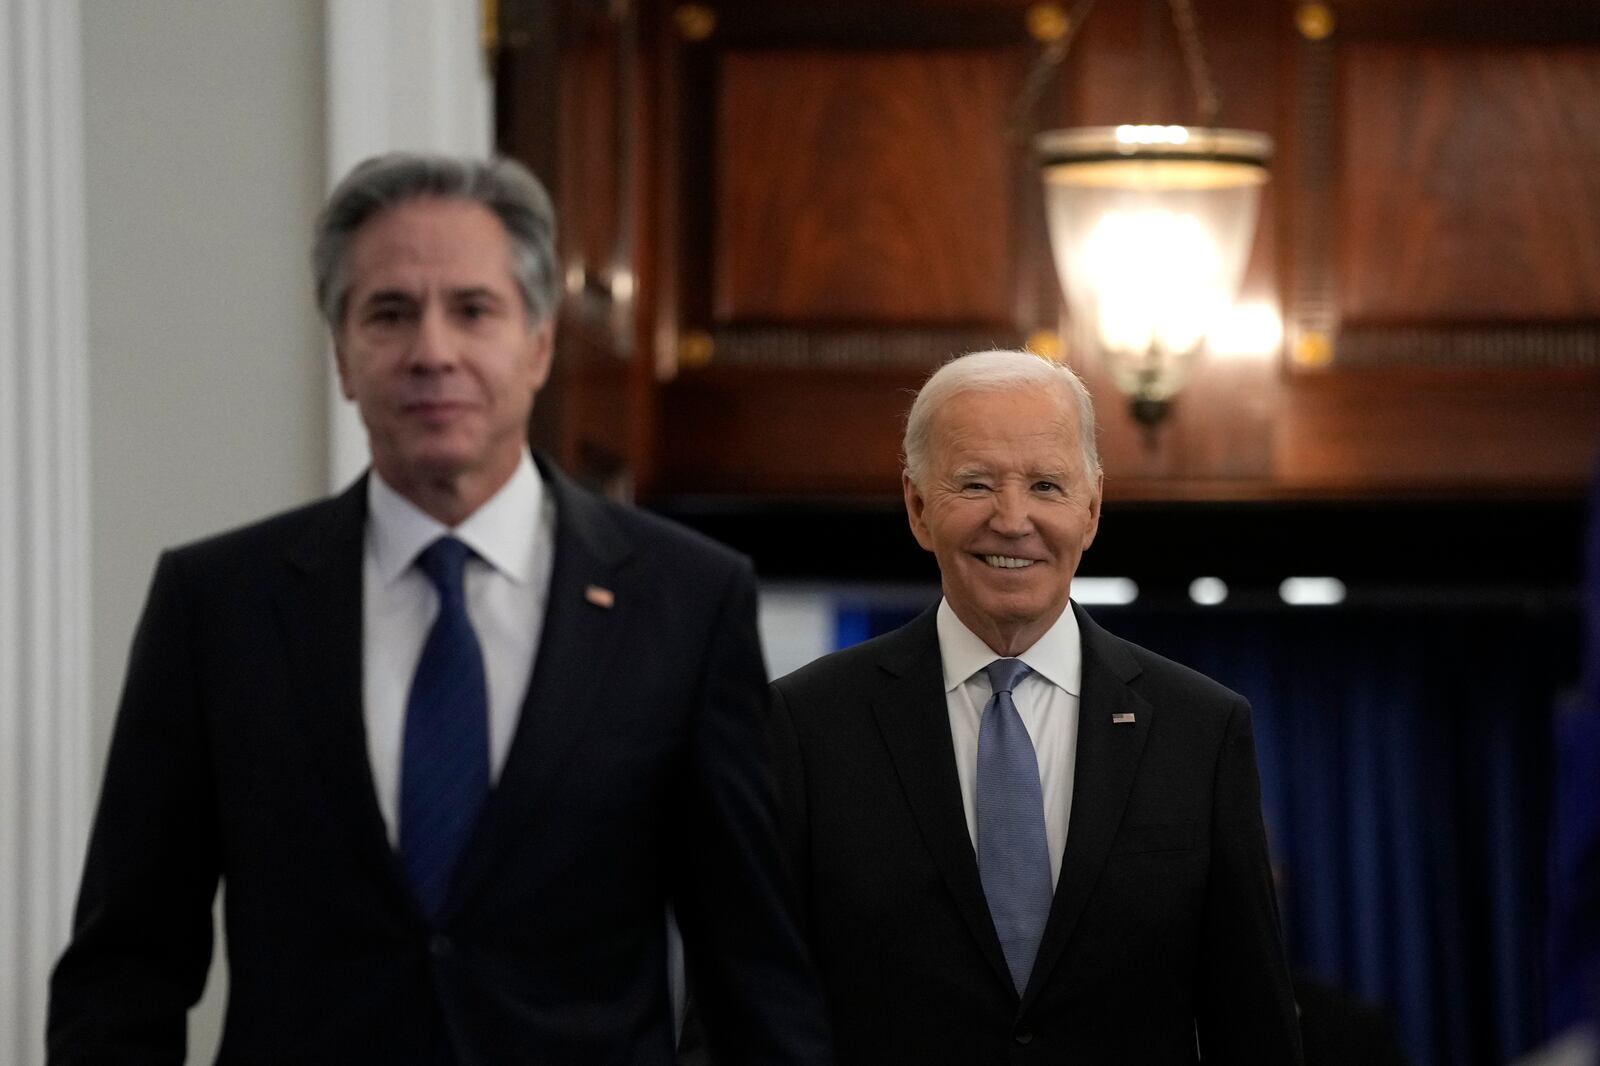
top-left (325, 0), bottom-right (493, 490)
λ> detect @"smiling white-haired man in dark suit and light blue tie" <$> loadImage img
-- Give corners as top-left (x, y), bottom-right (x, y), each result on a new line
top-left (773, 352), bottom-right (1301, 1066)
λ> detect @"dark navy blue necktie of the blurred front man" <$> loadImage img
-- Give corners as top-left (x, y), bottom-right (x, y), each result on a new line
top-left (400, 536), bottom-right (490, 919)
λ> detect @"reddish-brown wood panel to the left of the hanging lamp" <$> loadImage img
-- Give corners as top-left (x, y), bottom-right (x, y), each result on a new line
top-left (654, 3), bottom-right (1058, 372)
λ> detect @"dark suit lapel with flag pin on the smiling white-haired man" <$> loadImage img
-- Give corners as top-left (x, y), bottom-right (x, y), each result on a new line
top-left (1022, 603), bottom-right (1155, 1010)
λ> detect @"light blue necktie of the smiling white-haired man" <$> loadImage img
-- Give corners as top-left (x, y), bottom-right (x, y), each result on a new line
top-left (978, 659), bottom-right (1053, 996)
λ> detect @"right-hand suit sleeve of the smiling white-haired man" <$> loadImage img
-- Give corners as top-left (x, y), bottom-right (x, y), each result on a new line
top-left (1195, 699), bottom-right (1302, 1066)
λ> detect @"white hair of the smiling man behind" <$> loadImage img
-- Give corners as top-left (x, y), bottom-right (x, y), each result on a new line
top-left (904, 351), bottom-right (1101, 485)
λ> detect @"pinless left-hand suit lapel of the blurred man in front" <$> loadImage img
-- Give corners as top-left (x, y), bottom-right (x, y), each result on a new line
top-left (275, 477), bottom-right (410, 901)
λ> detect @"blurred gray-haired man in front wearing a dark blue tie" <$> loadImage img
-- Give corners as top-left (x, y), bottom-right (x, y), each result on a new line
top-left (48, 154), bottom-right (829, 1066)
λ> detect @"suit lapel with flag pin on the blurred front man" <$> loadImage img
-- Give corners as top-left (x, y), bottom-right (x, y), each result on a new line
top-left (446, 456), bottom-right (632, 914)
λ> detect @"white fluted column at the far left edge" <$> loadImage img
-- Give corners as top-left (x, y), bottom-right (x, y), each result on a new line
top-left (0, 0), bottom-right (93, 1066)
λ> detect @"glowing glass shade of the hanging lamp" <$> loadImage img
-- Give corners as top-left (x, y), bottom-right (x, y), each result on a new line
top-left (1035, 126), bottom-right (1272, 424)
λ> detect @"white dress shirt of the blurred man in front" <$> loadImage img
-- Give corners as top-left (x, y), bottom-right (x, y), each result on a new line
top-left (362, 451), bottom-right (555, 844)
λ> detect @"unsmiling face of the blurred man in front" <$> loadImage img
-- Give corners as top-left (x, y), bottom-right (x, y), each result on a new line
top-left (334, 198), bottom-right (550, 525)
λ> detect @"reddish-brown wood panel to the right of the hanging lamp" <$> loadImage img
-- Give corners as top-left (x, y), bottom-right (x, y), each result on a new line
top-left (1285, 2), bottom-right (1600, 373)
